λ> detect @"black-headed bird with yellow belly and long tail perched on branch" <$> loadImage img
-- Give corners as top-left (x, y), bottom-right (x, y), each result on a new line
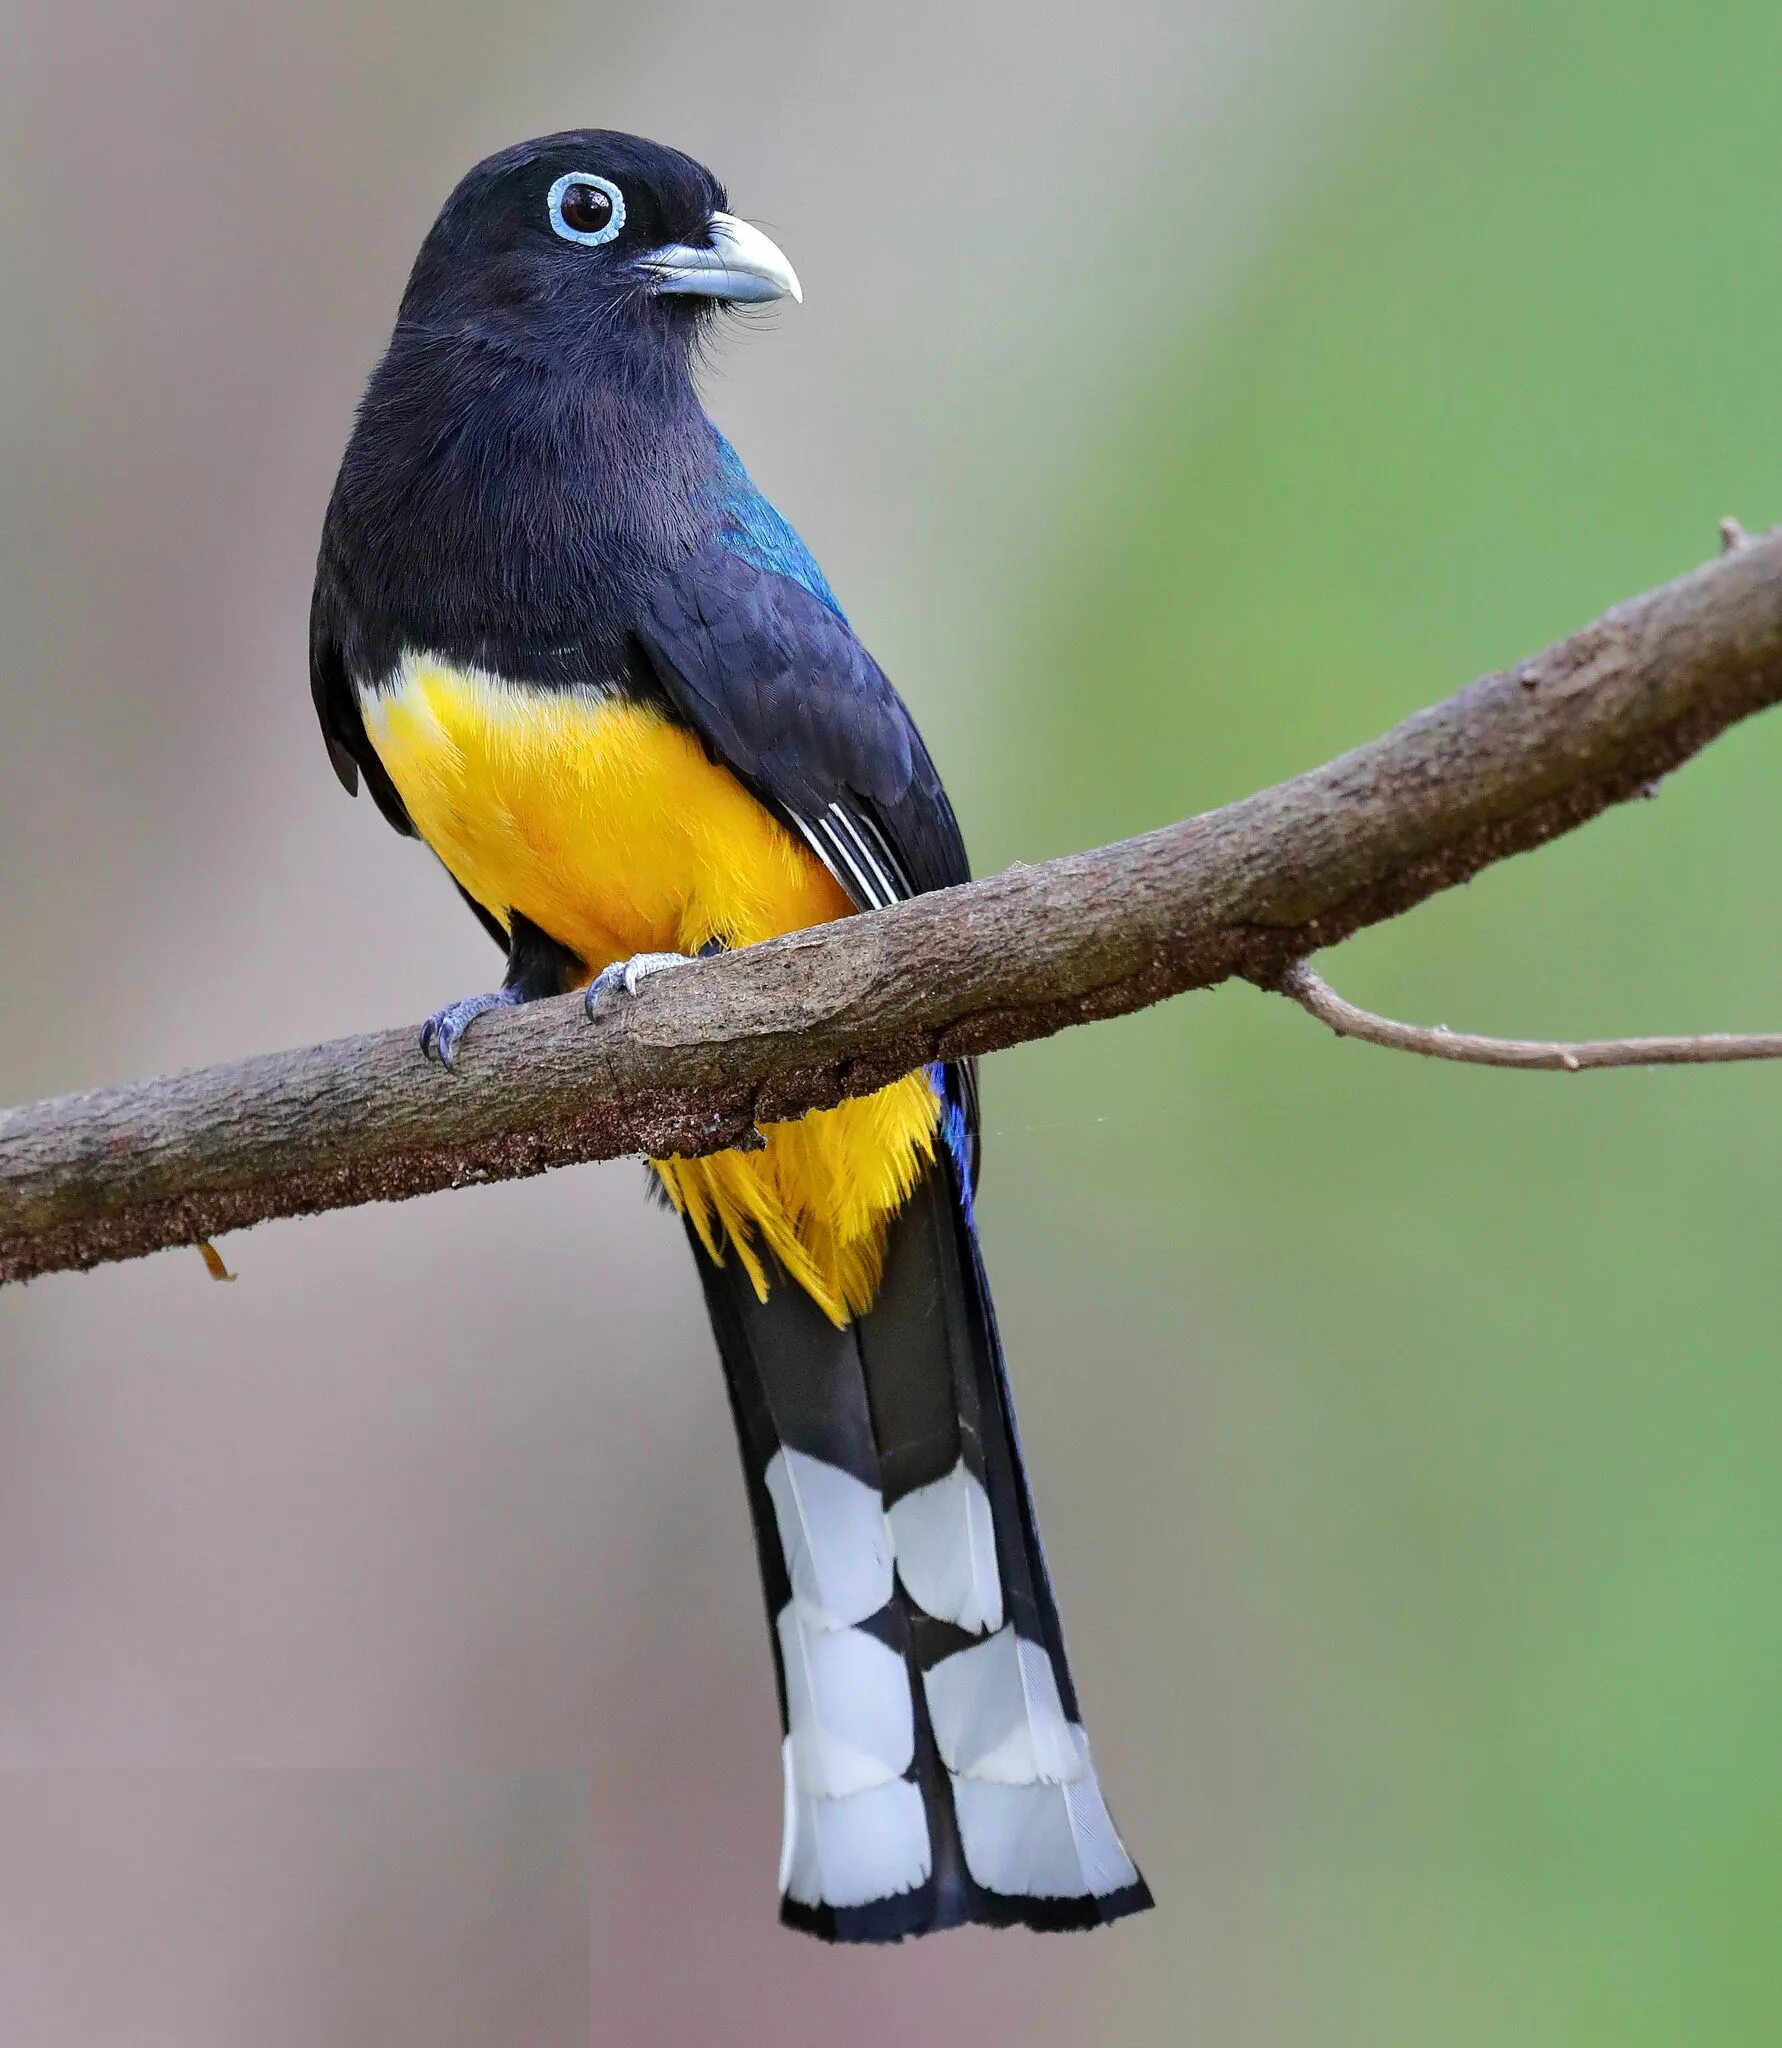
top-left (309, 129), bottom-right (1151, 1942)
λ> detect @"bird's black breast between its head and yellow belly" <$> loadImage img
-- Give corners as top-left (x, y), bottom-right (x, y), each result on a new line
top-left (317, 322), bottom-right (717, 686)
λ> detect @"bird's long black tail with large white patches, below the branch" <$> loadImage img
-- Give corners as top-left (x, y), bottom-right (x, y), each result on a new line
top-left (694, 1155), bottom-right (1151, 1942)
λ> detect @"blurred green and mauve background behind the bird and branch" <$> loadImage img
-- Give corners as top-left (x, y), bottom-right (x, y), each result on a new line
top-left (0, 0), bottom-right (1782, 2048)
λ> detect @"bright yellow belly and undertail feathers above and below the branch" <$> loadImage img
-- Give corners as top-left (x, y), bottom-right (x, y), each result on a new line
top-left (360, 655), bottom-right (940, 1323)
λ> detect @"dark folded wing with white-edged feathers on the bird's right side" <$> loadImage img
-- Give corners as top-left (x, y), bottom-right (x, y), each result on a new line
top-left (637, 541), bottom-right (977, 1180)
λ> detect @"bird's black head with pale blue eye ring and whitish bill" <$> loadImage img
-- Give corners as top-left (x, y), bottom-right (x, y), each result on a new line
top-left (401, 129), bottom-right (801, 354)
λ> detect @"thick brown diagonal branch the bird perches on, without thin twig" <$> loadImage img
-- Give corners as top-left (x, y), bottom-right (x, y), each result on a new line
top-left (0, 530), bottom-right (1782, 1280)
